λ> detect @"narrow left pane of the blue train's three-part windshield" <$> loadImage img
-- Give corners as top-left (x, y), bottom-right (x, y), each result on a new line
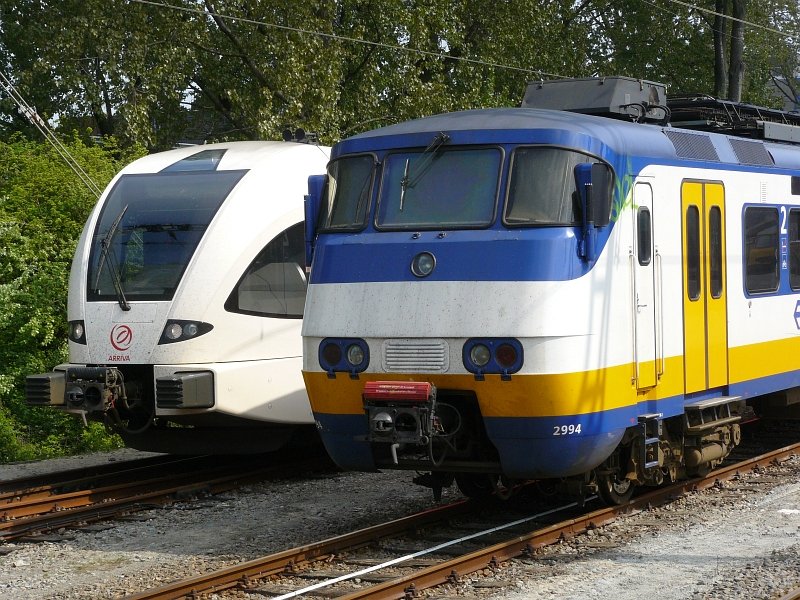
top-left (319, 154), bottom-right (375, 231)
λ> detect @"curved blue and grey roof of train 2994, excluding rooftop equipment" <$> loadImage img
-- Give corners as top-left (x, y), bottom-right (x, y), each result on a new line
top-left (332, 108), bottom-right (800, 169)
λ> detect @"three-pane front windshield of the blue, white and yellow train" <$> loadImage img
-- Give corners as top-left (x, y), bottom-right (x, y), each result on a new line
top-left (320, 146), bottom-right (599, 232)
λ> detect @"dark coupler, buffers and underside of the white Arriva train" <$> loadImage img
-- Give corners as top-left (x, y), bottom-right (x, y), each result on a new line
top-left (26, 365), bottom-right (319, 455)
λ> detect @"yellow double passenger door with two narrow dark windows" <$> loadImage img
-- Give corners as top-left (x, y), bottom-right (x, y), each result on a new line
top-left (681, 181), bottom-right (728, 394)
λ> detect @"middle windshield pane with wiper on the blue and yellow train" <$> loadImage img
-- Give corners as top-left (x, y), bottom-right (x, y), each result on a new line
top-left (375, 145), bottom-right (503, 229)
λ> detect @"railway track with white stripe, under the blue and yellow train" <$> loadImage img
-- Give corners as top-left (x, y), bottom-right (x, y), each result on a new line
top-left (122, 444), bottom-right (800, 600)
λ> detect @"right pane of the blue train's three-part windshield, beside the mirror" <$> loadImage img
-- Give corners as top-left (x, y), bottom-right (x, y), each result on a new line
top-left (504, 147), bottom-right (600, 225)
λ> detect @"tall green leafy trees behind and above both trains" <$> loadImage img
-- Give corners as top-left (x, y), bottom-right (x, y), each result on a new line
top-left (0, 0), bottom-right (798, 149)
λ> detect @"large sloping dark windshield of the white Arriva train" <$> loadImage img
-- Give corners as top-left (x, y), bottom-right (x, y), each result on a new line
top-left (87, 171), bottom-right (245, 301)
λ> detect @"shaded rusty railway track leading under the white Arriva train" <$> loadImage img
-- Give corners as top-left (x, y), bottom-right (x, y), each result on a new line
top-left (0, 451), bottom-right (329, 542)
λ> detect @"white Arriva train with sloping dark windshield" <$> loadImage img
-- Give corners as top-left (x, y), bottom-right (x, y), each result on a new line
top-left (26, 142), bottom-right (329, 453)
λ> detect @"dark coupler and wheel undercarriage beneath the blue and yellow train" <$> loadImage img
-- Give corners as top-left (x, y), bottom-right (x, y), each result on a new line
top-left (364, 382), bottom-right (747, 504)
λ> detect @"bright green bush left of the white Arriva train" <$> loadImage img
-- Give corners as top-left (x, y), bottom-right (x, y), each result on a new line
top-left (0, 136), bottom-right (141, 463)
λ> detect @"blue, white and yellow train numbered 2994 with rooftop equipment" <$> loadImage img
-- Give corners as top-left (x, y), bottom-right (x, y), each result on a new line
top-left (303, 78), bottom-right (800, 503)
